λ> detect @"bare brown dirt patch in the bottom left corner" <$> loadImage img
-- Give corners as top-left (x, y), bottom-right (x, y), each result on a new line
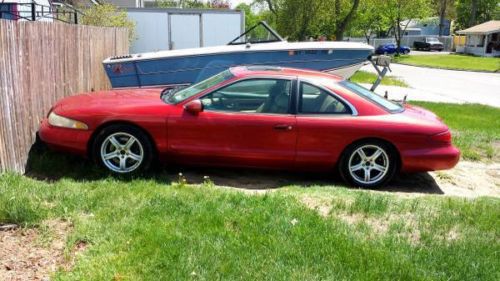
top-left (0, 220), bottom-right (76, 281)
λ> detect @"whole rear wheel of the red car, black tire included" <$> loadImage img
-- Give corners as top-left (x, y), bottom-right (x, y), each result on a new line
top-left (339, 140), bottom-right (399, 188)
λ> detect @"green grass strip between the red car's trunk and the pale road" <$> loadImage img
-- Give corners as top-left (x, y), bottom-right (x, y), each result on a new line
top-left (412, 102), bottom-right (500, 161)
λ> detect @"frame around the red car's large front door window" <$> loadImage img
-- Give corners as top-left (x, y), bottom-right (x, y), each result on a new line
top-left (195, 76), bottom-right (297, 116)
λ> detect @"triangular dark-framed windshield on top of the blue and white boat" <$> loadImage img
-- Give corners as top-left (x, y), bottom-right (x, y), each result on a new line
top-left (228, 21), bottom-right (285, 45)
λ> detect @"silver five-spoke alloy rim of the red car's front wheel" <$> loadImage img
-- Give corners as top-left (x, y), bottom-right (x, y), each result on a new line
top-left (101, 132), bottom-right (144, 173)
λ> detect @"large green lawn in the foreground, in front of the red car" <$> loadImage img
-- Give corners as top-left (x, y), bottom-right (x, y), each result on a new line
top-left (0, 165), bottom-right (500, 280)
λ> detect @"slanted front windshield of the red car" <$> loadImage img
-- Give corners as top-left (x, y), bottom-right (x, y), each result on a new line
top-left (163, 70), bottom-right (234, 104)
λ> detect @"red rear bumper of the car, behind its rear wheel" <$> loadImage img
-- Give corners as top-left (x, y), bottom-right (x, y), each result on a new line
top-left (401, 145), bottom-right (460, 172)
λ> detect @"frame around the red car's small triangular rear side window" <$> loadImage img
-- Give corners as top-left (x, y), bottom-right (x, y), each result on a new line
top-left (294, 79), bottom-right (358, 116)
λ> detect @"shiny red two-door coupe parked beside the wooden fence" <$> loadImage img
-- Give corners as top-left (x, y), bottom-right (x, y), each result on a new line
top-left (39, 67), bottom-right (460, 187)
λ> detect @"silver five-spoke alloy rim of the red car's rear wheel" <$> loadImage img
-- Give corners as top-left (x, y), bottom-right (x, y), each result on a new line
top-left (348, 144), bottom-right (389, 185)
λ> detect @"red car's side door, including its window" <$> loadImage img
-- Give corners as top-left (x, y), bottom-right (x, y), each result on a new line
top-left (168, 78), bottom-right (297, 167)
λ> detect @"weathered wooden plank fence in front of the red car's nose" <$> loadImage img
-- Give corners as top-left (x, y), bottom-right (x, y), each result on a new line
top-left (0, 20), bottom-right (128, 172)
